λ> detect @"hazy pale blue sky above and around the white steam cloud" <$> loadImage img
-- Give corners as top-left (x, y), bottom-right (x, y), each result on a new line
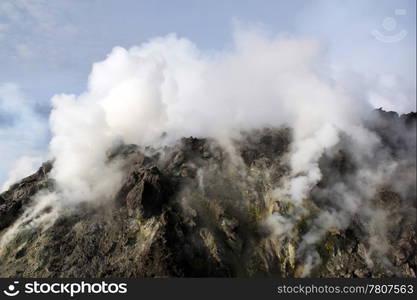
top-left (0, 0), bottom-right (416, 186)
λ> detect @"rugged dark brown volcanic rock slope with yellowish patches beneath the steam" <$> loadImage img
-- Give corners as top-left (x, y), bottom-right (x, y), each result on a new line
top-left (0, 111), bottom-right (417, 277)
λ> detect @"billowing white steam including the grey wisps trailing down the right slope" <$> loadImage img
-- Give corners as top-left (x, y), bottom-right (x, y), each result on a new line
top-left (1, 30), bottom-right (414, 275)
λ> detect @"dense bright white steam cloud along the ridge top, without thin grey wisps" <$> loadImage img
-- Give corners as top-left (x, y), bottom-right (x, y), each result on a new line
top-left (50, 30), bottom-right (372, 202)
